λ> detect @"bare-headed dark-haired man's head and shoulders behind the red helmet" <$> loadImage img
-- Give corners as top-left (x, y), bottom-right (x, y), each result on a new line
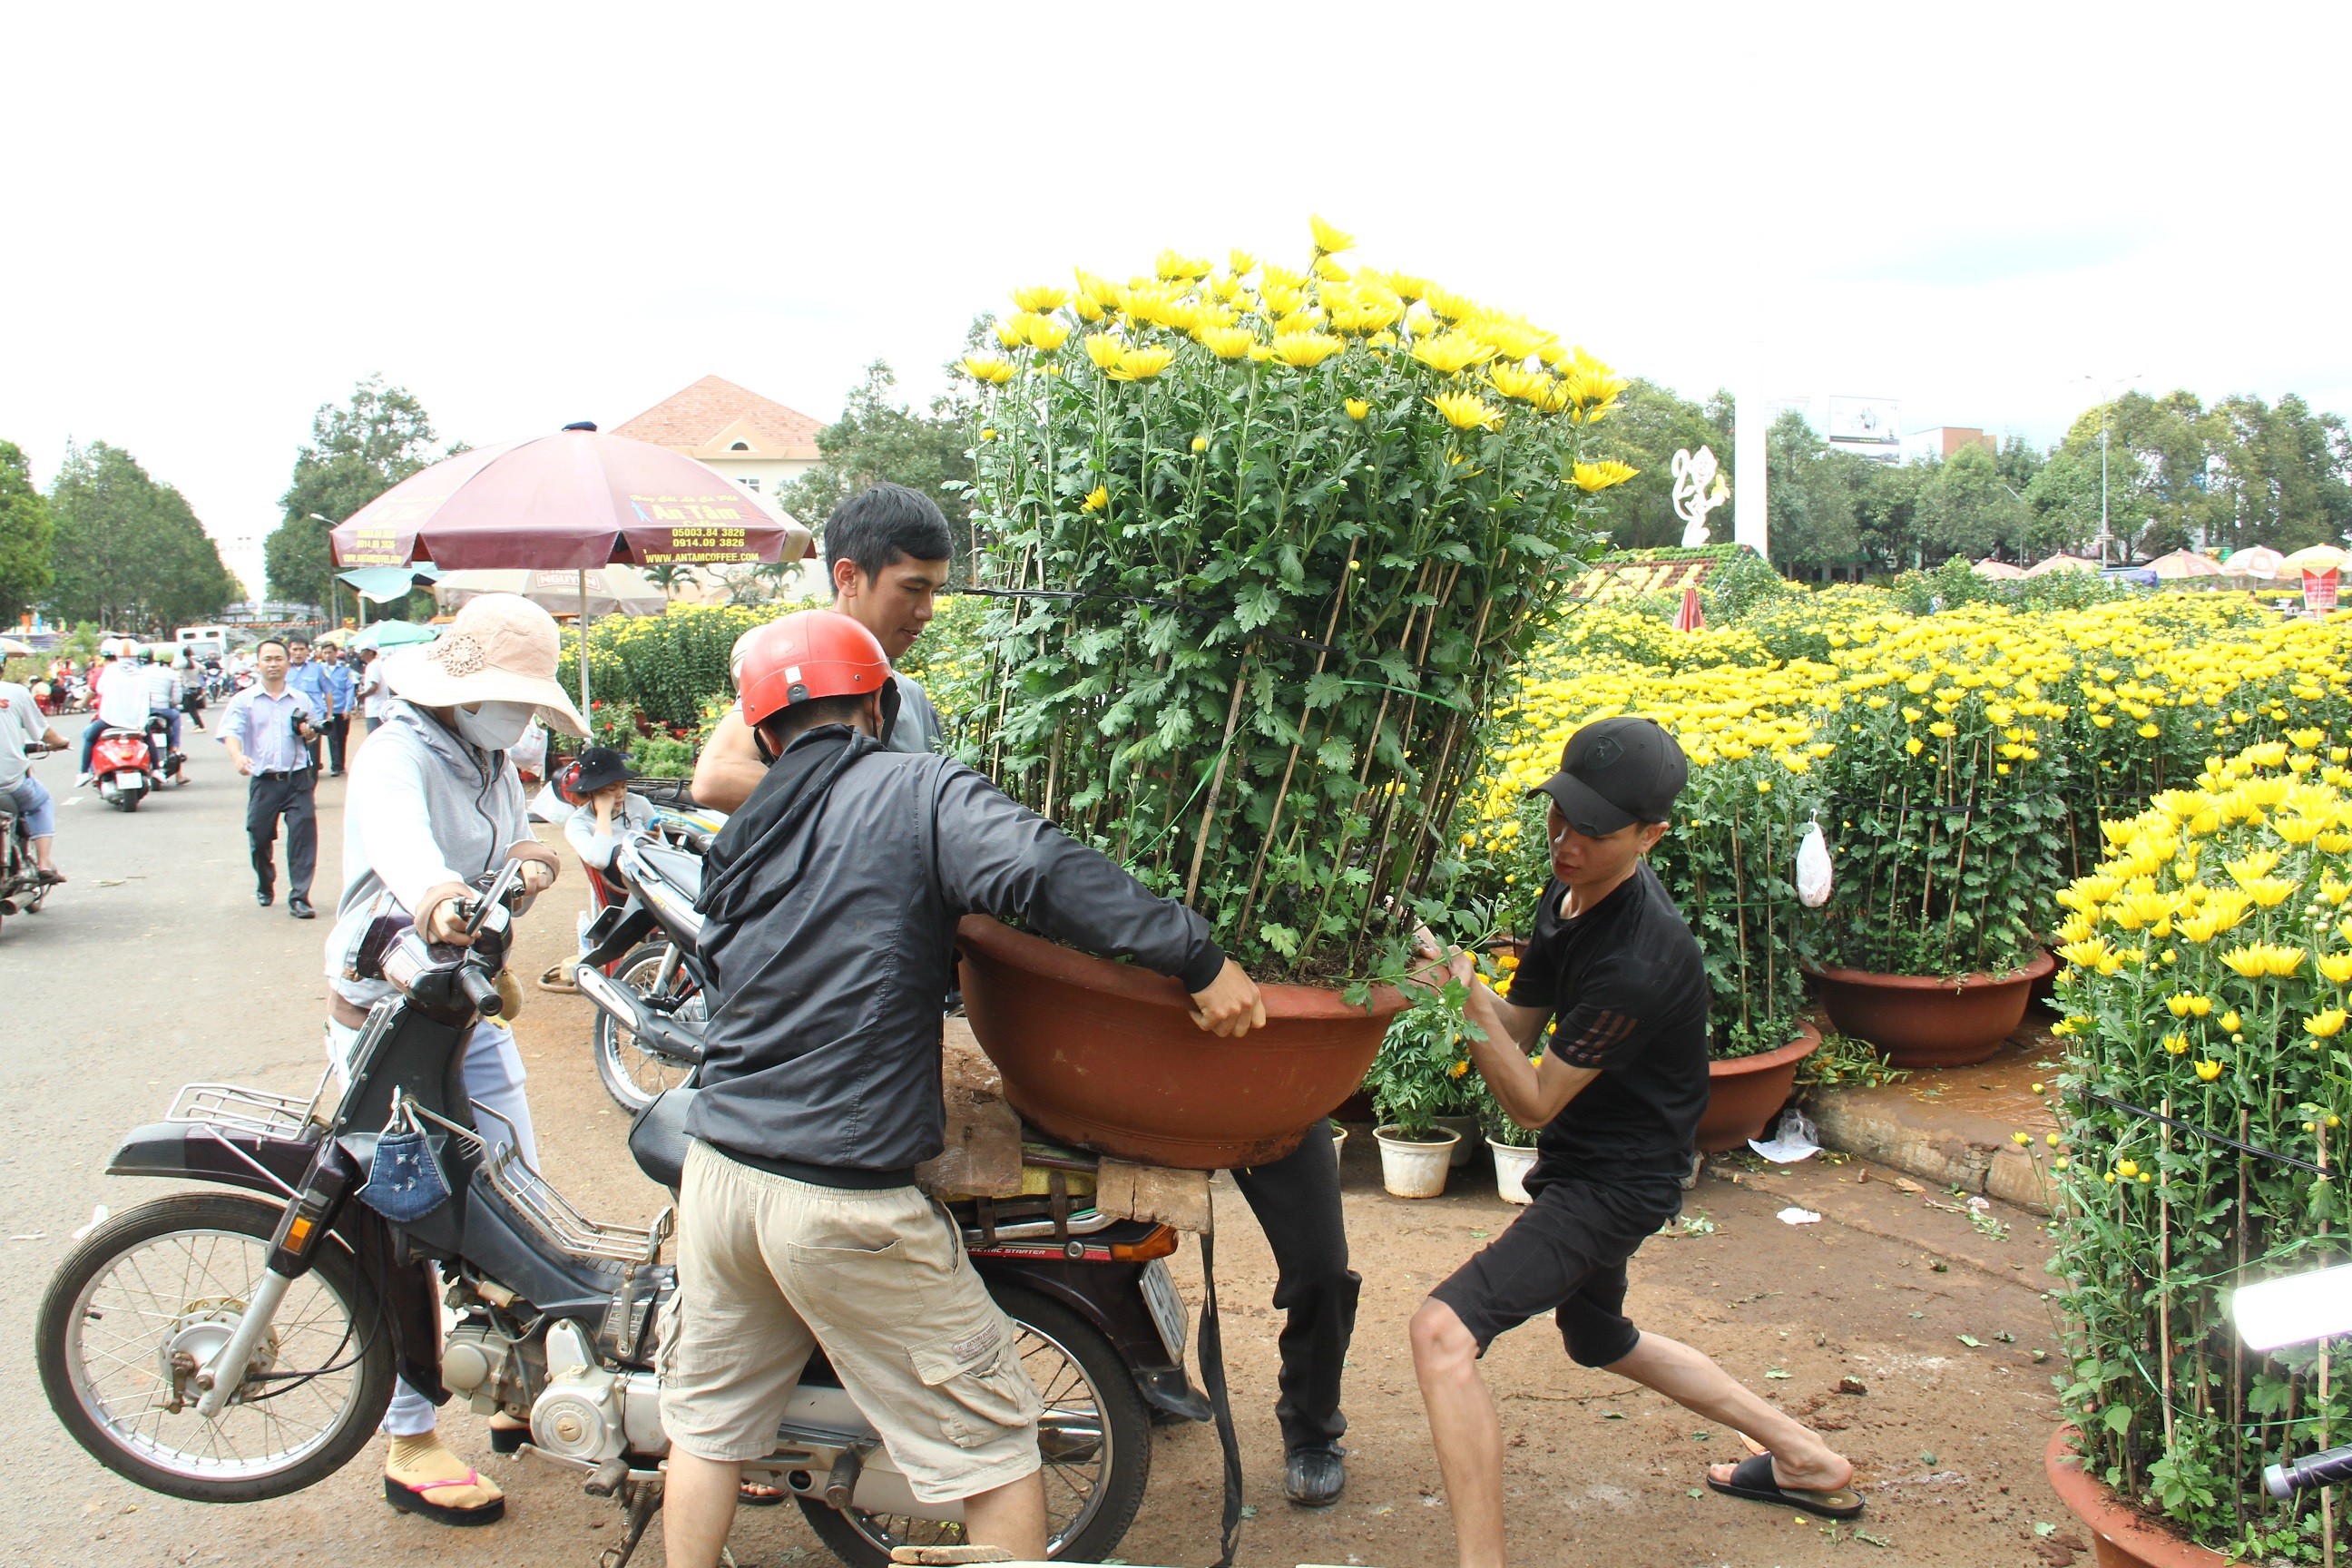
top-left (694, 485), bottom-right (955, 811)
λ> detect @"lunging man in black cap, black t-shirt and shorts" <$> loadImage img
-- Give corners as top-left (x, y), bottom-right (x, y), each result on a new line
top-left (1411, 720), bottom-right (1863, 1568)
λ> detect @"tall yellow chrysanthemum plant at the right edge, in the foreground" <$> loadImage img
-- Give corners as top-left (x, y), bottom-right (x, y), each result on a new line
top-left (2051, 727), bottom-right (2352, 1561)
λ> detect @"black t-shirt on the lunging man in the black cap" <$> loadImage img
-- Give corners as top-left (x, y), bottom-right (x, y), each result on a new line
top-left (1510, 860), bottom-right (1708, 1181)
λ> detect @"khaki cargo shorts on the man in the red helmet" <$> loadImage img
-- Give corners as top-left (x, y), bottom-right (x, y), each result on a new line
top-left (661, 1142), bottom-right (1044, 1502)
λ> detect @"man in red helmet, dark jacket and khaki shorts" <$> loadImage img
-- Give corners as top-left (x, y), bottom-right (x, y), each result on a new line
top-left (661, 609), bottom-right (1265, 1568)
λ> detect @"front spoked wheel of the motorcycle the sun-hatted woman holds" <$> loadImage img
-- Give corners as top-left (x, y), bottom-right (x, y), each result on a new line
top-left (35, 1191), bottom-right (393, 1502)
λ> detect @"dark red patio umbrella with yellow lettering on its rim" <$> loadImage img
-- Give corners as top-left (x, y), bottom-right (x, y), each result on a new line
top-left (329, 423), bottom-right (809, 712)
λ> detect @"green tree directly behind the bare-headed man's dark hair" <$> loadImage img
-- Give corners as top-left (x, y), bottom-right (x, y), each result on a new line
top-left (776, 359), bottom-right (971, 583)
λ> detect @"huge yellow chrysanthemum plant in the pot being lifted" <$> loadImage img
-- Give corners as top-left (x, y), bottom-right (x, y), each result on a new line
top-left (965, 221), bottom-right (1632, 980)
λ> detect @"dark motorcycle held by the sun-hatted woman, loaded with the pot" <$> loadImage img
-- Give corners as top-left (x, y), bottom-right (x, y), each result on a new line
top-left (35, 863), bottom-right (1209, 1568)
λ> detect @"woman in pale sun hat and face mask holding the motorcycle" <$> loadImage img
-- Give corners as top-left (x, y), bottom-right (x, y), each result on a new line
top-left (327, 593), bottom-right (588, 1524)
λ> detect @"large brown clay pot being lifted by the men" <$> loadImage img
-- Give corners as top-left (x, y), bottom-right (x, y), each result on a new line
top-left (955, 915), bottom-right (1404, 1171)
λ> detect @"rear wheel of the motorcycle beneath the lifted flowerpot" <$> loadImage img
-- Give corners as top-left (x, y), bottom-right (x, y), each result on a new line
top-left (795, 1281), bottom-right (1152, 1568)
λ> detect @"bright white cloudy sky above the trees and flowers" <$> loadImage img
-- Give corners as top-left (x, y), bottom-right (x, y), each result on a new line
top-left (0, 0), bottom-right (2352, 588)
